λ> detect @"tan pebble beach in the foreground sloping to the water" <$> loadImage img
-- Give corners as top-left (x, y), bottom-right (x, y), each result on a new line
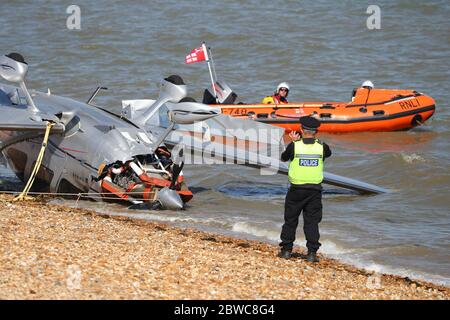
top-left (0, 195), bottom-right (450, 300)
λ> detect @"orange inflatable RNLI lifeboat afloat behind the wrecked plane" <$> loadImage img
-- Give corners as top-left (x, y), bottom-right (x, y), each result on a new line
top-left (221, 87), bottom-right (435, 132)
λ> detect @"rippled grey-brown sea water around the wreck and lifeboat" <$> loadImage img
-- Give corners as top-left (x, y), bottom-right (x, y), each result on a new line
top-left (0, 0), bottom-right (450, 285)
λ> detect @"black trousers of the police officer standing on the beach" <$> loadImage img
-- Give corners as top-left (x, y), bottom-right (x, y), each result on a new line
top-left (280, 187), bottom-right (322, 252)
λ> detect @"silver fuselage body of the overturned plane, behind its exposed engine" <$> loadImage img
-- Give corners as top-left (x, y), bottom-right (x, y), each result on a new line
top-left (0, 84), bottom-right (158, 193)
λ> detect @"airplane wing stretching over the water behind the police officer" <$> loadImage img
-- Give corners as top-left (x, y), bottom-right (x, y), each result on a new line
top-left (165, 115), bottom-right (388, 194)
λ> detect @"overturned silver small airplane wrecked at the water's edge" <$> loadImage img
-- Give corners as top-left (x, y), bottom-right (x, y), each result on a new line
top-left (0, 53), bottom-right (386, 210)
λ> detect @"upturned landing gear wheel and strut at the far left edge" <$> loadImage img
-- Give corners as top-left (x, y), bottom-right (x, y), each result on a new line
top-left (0, 52), bottom-right (39, 112)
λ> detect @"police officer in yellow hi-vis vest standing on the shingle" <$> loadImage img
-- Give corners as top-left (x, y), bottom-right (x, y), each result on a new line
top-left (278, 117), bottom-right (331, 262)
